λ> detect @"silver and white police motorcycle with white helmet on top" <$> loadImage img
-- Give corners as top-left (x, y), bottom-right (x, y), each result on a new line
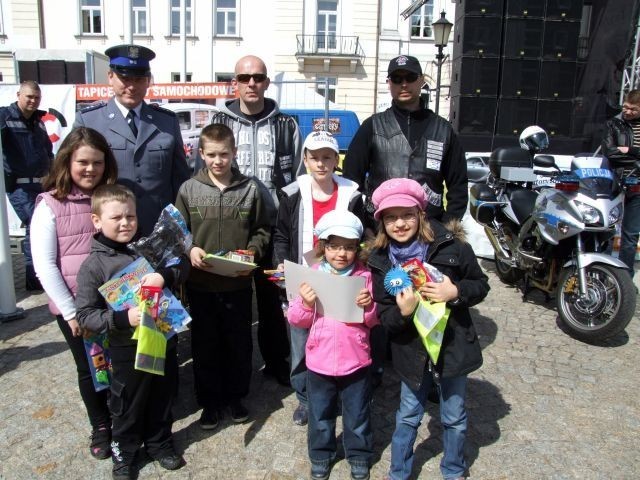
top-left (469, 126), bottom-right (636, 342)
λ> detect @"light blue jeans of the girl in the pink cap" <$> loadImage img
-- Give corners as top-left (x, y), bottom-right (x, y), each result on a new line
top-left (389, 369), bottom-right (467, 480)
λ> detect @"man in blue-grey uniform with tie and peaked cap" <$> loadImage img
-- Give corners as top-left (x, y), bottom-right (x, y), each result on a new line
top-left (73, 45), bottom-right (191, 236)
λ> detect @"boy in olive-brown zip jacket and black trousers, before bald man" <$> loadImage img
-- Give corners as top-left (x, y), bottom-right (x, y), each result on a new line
top-left (176, 124), bottom-right (270, 430)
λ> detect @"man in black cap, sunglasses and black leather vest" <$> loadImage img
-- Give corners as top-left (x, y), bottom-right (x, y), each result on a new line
top-left (343, 55), bottom-right (468, 231)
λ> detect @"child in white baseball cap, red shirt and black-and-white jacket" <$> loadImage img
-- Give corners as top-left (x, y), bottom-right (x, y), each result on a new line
top-left (273, 131), bottom-right (363, 425)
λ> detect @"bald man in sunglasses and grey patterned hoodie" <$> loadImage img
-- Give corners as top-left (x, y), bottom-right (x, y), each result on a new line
top-left (195, 55), bottom-right (305, 386)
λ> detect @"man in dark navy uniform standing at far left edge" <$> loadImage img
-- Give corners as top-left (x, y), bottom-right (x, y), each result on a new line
top-left (0, 80), bottom-right (53, 290)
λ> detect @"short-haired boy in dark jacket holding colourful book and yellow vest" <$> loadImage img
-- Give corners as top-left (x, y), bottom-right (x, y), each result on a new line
top-left (76, 185), bottom-right (189, 480)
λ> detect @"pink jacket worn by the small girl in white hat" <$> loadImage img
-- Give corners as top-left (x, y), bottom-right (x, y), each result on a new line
top-left (287, 262), bottom-right (380, 377)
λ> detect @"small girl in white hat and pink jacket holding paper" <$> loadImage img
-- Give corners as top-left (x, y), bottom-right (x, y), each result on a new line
top-left (288, 210), bottom-right (378, 480)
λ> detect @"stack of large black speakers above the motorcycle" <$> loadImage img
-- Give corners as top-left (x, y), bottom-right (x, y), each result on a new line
top-left (450, 0), bottom-right (640, 155)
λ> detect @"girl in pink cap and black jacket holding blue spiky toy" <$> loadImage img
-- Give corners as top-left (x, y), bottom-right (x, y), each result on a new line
top-left (368, 178), bottom-right (489, 480)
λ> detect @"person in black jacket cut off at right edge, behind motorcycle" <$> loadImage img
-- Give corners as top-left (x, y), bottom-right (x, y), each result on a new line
top-left (602, 90), bottom-right (640, 278)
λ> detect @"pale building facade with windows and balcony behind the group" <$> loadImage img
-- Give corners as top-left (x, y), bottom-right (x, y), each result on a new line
top-left (0, 0), bottom-right (455, 121)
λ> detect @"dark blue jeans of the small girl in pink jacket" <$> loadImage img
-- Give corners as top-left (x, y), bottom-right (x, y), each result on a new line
top-left (307, 367), bottom-right (373, 465)
